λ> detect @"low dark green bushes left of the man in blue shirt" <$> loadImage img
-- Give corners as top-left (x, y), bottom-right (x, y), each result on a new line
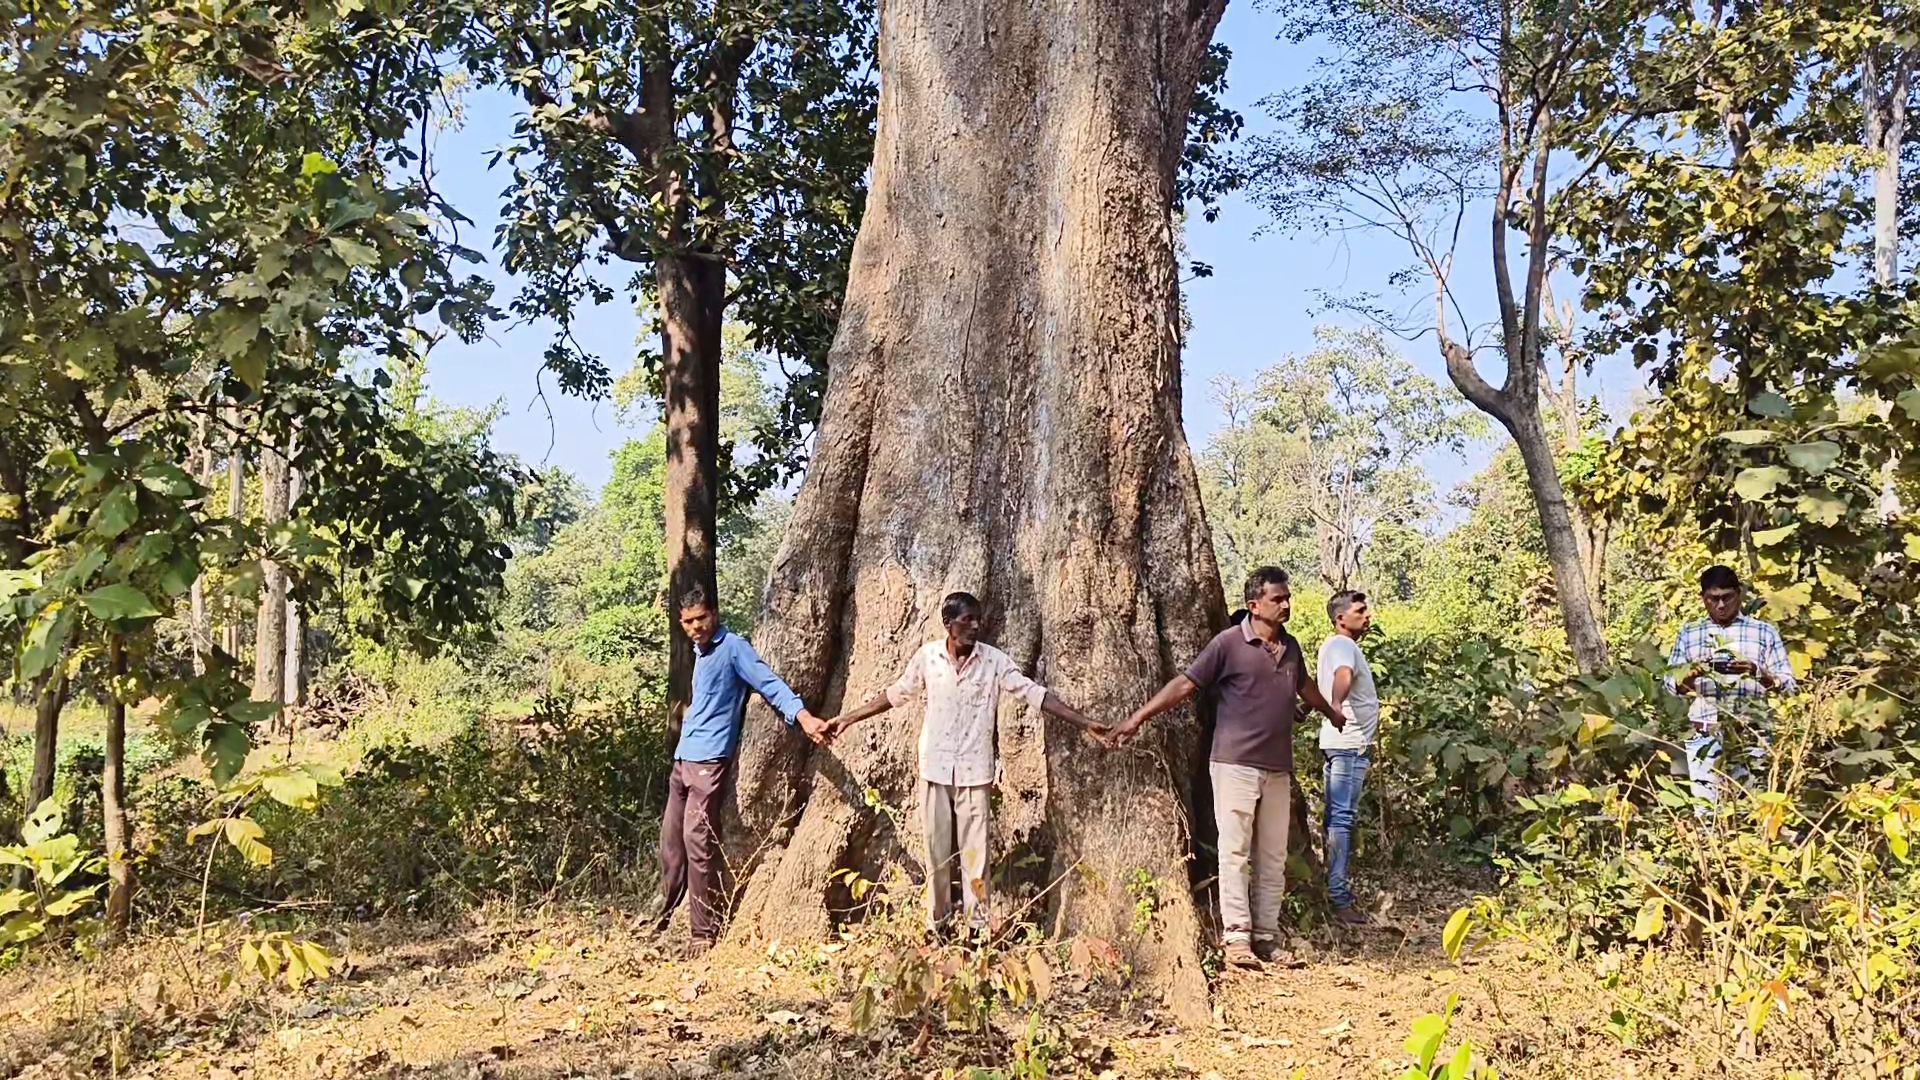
top-left (134, 684), bottom-right (666, 920)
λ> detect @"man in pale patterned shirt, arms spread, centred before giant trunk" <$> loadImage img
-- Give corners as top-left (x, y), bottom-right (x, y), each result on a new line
top-left (831, 592), bottom-right (1104, 930)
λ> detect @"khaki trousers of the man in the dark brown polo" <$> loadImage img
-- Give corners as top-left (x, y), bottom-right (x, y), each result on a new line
top-left (1208, 761), bottom-right (1292, 942)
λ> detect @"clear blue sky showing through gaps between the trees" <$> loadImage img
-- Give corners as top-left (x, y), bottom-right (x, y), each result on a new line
top-left (416, 0), bottom-right (1636, 488)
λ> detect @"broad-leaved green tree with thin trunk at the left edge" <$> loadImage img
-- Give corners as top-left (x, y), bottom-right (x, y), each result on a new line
top-left (0, 0), bottom-right (507, 924)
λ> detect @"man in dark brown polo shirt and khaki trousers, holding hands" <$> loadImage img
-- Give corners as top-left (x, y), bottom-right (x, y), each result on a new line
top-left (1114, 567), bottom-right (1346, 969)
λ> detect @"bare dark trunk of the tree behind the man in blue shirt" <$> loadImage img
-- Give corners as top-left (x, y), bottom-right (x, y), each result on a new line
top-left (655, 256), bottom-right (726, 746)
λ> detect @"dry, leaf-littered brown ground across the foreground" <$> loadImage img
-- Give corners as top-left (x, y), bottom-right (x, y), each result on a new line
top-left (0, 868), bottom-right (1743, 1080)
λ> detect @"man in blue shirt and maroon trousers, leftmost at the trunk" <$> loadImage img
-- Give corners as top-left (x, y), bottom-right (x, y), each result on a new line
top-left (657, 586), bottom-right (828, 957)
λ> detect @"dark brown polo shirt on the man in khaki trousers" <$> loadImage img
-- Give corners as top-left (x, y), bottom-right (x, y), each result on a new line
top-left (1187, 617), bottom-right (1308, 773)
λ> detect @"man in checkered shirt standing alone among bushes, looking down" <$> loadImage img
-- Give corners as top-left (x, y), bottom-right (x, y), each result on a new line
top-left (1667, 567), bottom-right (1793, 815)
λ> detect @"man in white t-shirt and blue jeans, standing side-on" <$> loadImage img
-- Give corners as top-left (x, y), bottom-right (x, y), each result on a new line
top-left (1313, 590), bottom-right (1380, 926)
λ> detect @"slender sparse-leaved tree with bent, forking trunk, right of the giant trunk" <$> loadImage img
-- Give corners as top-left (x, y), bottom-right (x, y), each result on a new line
top-left (1244, 0), bottom-right (1661, 671)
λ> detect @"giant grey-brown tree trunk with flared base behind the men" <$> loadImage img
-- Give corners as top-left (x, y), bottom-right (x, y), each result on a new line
top-left (721, 0), bottom-right (1225, 1022)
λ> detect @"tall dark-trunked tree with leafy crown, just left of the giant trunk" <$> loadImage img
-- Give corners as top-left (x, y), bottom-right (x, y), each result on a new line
top-left (468, 0), bottom-right (874, 730)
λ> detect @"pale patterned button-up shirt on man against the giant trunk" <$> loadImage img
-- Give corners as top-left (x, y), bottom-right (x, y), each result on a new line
top-left (887, 640), bottom-right (1046, 788)
